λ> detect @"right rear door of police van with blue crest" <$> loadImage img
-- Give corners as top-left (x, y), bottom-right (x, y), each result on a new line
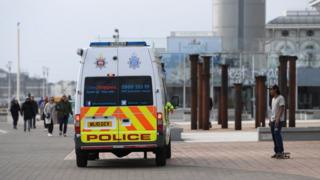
top-left (118, 47), bottom-right (157, 142)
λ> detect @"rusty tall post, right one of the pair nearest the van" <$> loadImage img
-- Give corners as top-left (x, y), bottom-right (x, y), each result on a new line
top-left (202, 56), bottom-right (211, 130)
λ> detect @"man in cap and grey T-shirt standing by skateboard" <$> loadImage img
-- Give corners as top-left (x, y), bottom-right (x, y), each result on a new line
top-left (269, 85), bottom-right (285, 158)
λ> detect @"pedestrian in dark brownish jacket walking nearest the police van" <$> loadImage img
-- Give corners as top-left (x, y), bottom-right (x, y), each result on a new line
top-left (56, 95), bottom-right (73, 137)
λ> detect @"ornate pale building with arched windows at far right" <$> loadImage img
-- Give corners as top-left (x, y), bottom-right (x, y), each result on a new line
top-left (265, 10), bottom-right (320, 110)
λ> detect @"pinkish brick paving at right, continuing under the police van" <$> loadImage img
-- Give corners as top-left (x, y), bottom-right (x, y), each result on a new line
top-left (65, 141), bottom-right (320, 178)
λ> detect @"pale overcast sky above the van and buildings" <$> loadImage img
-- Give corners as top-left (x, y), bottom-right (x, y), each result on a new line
top-left (0, 0), bottom-right (310, 82)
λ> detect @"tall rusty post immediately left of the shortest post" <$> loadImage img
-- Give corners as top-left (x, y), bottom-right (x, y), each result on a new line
top-left (219, 64), bottom-right (228, 129)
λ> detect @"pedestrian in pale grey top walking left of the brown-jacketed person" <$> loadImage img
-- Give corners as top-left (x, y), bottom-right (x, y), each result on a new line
top-left (44, 97), bottom-right (55, 136)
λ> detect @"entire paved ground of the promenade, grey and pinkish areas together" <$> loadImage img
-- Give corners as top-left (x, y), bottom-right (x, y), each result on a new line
top-left (0, 123), bottom-right (320, 180)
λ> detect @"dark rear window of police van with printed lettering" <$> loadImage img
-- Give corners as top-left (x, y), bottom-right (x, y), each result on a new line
top-left (84, 76), bottom-right (153, 106)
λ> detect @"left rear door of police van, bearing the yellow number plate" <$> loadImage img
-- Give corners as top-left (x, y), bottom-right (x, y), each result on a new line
top-left (80, 47), bottom-right (119, 143)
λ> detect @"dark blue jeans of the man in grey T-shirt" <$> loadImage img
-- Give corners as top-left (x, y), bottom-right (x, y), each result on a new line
top-left (270, 121), bottom-right (285, 153)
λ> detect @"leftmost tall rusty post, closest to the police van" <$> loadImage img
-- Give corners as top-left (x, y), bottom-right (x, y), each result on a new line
top-left (190, 54), bottom-right (199, 130)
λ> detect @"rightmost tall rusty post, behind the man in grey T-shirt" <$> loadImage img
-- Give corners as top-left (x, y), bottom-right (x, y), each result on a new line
top-left (288, 56), bottom-right (298, 127)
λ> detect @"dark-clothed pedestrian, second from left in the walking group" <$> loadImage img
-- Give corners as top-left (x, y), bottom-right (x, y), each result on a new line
top-left (21, 97), bottom-right (35, 132)
